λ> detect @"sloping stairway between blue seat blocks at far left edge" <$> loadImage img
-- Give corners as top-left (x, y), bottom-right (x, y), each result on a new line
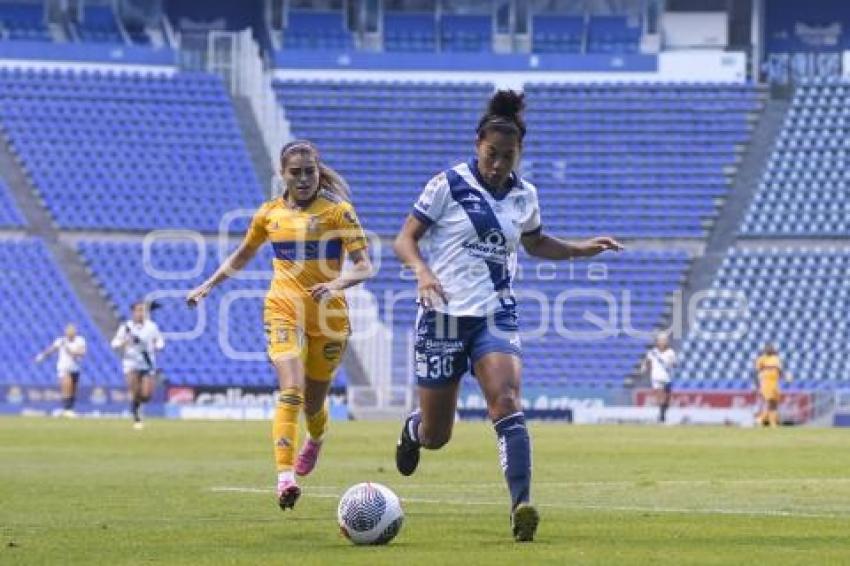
top-left (0, 135), bottom-right (120, 336)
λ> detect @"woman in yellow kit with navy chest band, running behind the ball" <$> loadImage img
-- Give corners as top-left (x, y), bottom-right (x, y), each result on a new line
top-left (186, 141), bottom-right (372, 509)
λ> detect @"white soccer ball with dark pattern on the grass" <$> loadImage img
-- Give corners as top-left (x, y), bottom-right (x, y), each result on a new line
top-left (336, 482), bottom-right (404, 544)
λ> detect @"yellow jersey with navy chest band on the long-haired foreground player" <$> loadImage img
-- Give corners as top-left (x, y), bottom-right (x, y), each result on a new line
top-left (245, 190), bottom-right (366, 318)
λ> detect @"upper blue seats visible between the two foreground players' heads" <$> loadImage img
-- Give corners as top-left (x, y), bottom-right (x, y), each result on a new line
top-left (275, 81), bottom-right (493, 235)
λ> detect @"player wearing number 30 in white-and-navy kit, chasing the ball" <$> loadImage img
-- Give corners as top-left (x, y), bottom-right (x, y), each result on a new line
top-left (395, 91), bottom-right (622, 541)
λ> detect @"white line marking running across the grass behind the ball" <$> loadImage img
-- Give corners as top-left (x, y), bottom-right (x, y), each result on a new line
top-left (210, 484), bottom-right (850, 519)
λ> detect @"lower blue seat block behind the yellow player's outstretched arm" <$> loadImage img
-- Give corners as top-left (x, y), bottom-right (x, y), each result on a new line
top-left (78, 241), bottom-right (344, 387)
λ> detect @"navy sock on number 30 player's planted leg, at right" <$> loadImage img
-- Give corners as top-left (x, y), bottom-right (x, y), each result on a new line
top-left (493, 413), bottom-right (531, 509)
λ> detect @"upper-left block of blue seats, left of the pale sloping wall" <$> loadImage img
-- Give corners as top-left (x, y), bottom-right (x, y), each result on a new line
top-left (0, 69), bottom-right (264, 232)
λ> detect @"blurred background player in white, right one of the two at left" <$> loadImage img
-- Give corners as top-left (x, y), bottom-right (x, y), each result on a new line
top-left (112, 302), bottom-right (165, 430)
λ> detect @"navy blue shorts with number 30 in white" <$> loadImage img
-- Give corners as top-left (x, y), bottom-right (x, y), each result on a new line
top-left (413, 308), bottom-right (522, 387)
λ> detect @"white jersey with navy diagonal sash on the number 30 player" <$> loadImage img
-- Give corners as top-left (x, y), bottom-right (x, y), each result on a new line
top-left (413, 159), bottom-right (542, 316)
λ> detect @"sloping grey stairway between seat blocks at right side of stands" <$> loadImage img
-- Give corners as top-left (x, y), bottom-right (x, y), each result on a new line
top-left (682, 99), bottom-right (789, 340)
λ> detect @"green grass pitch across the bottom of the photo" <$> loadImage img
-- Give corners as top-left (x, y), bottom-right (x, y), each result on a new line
top-left (0, 418), bottom-right (850, 566)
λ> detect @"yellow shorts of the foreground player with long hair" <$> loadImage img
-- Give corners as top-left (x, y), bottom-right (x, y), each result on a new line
top-left (265, 319), bottom-right (348, 381)
